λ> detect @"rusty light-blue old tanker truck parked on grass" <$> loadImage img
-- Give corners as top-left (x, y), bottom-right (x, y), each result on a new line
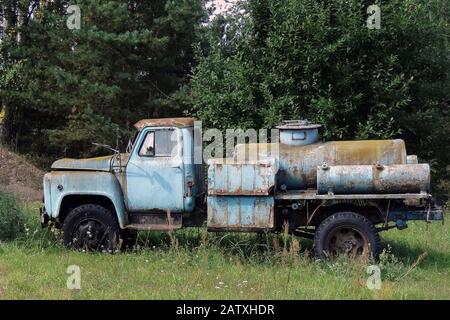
top-left (40, 118), bottom-right (444, 259)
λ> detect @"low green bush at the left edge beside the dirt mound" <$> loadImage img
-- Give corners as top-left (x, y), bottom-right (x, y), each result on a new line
top-left (0, 193), bottom-right (26, 241)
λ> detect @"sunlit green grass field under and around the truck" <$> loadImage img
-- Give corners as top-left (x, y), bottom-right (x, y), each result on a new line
top-left (0, 203), bottom-right (450, 299)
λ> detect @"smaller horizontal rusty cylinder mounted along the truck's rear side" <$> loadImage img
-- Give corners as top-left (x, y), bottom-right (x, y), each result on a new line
top-left (317, 164), bottom-right (430, 194)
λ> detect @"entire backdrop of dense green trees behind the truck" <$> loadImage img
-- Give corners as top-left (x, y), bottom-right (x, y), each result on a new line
top-left (0, 0), bottom-right (450, 197)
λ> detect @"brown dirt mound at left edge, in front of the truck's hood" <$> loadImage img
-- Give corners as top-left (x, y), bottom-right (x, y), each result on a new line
top-left (0, 146), bottom-right (44, 201)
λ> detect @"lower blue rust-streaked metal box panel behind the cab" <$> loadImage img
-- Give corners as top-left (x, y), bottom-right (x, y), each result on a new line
top-left (207, 196), bottom-right (274, 231)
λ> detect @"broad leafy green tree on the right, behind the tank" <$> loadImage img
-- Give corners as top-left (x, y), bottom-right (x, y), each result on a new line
top-left (191, 0), bottom-right (450, 195)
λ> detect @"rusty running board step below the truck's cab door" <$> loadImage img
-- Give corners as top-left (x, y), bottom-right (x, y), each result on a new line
top-left (127, 212), bottom-right (183, 231)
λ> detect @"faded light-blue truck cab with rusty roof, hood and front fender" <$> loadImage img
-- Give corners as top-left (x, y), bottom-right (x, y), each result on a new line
top-left (41, 118), bottom-right (201, 248)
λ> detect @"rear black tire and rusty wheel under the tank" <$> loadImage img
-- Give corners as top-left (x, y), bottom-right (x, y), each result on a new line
top-left (314, 212), bottom-right (380, 260)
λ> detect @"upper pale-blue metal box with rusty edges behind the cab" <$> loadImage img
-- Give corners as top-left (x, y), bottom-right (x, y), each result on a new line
top-left (208, 158), bottom-right (277, 196)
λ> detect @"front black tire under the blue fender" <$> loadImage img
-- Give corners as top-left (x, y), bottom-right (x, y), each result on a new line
top-left (63, 204), bottom-right (122, 253)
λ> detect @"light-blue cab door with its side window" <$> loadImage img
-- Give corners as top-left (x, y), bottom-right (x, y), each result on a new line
top-left (125, 128), bottom-right (184, 212)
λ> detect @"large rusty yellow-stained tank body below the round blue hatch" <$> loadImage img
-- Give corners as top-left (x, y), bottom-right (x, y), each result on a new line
top-left (235, 139), bottom-right (406, 190)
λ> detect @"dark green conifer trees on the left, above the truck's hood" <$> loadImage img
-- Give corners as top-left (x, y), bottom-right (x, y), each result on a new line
top-left (0, 0), bottom-right (203, 158)
